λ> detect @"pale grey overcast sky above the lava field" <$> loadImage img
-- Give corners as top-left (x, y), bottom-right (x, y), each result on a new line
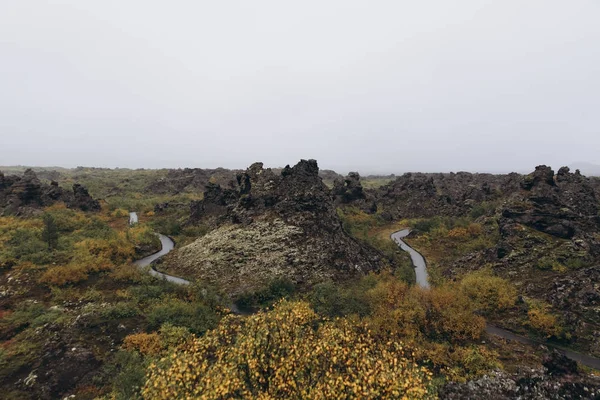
top-left (0, 0), bottom-right (600, 172)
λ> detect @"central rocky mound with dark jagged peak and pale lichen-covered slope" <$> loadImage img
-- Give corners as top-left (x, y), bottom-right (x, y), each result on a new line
top-left (167, 160), bottom-right (381, 295)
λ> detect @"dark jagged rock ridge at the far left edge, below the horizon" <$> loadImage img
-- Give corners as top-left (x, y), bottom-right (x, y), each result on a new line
top-left (0, 169), bottom-right (100, 215)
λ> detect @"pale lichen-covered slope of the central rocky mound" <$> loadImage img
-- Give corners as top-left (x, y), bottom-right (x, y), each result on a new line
top-left (169, 219), bottom-right (344, 294)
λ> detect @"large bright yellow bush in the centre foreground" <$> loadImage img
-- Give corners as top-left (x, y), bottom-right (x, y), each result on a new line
top-left (142, 301), bottom-right (432, 399)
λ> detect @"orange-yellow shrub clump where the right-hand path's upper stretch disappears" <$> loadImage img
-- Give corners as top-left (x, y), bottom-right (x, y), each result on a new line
top-left (358, 274), bottom-right (500, 380)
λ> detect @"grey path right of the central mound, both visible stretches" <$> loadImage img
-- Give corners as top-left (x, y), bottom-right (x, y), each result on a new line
top-left (390, 229), bottom-right (600, 370)
